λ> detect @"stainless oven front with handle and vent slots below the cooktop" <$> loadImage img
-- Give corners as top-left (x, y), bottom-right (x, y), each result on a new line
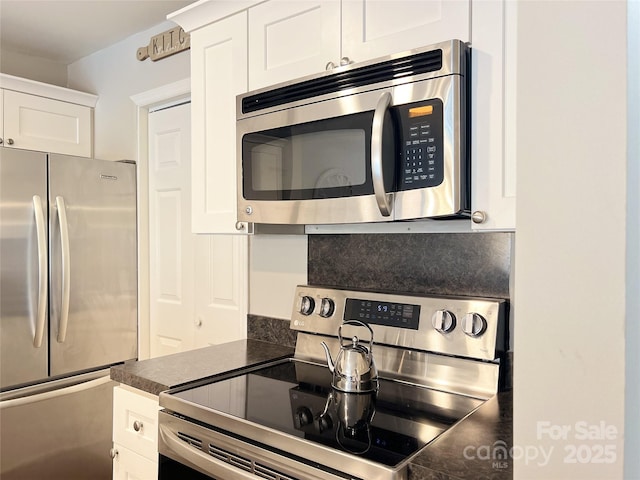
top-left (158, 410), bottom-right (362, 480)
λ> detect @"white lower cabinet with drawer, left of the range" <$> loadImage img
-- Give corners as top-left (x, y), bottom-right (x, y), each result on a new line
top-left (112, 386), bottom-right (160, 480)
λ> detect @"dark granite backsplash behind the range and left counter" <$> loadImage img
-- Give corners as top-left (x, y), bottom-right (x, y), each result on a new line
top-left (247, 232), bottom-right (514, 347)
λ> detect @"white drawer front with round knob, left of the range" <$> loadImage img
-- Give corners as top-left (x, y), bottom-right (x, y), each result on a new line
top-left (113, 387), bottom-right (159, 461)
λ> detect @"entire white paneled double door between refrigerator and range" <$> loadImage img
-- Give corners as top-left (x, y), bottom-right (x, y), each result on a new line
top-left (148, 104), bottom-right (248, 357)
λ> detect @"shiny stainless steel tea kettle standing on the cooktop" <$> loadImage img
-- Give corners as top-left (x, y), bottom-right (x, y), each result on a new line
top-left (322, 320), bottom-right (378, 393)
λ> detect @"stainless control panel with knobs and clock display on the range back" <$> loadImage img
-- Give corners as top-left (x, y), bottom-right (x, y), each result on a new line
top-left (291, 285), bottom-right (507, 360)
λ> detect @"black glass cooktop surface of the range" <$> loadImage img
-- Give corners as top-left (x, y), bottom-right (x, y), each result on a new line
top-left (171, 359), bottom-right (482, 466)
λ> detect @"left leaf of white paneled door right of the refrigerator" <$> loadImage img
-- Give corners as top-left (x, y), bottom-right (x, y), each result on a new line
top-left (149, 103), bottom-right (196, 357)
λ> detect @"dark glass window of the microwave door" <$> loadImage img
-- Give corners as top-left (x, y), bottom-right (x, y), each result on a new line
top-left (242, 112), bottom-right (380, 200)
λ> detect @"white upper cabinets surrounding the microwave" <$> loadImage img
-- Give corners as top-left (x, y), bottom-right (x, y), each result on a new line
top-left (172, 0), bottom-right (517, 233)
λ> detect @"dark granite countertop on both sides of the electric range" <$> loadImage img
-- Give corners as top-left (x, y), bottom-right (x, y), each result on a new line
top-left (111, 339), bottom-right (513, 480)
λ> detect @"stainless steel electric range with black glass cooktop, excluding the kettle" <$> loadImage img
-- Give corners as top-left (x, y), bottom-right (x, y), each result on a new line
top-left (159, 286), bottom-right (506, 480)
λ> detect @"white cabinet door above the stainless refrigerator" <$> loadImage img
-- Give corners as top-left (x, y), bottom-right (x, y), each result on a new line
top-left (3, 90), bottom-right (93, 157)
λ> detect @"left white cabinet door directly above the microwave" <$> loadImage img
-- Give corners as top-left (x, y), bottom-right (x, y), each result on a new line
top-left (249, 0), bottom-right (340, 90)
